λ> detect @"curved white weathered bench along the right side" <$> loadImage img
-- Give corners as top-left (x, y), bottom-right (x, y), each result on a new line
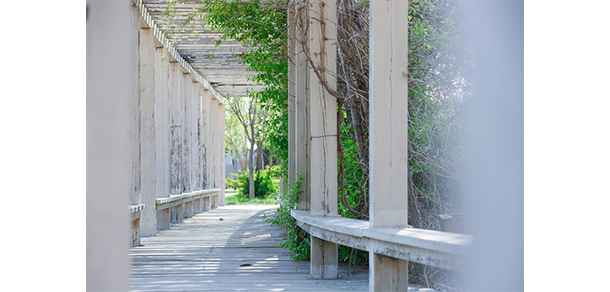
top-left (291, 210), bottom-right (472, 271)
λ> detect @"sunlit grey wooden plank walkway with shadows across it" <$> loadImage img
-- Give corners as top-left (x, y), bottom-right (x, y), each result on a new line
top-left (131, 205), bottom-right (368, 291)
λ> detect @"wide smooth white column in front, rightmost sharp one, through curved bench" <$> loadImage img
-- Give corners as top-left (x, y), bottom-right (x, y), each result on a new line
top-left (369, 0), bottom-right (409, 291)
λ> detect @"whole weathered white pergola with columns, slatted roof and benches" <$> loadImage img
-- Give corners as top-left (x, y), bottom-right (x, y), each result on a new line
top-left (87, 0), bottom-right (523, 291)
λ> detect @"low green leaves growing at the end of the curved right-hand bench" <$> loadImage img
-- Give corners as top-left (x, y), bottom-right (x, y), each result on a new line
top-left (265, 173), bottom-right (311, 261)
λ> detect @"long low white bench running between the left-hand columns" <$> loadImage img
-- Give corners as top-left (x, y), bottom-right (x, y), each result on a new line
top-left (156, 189), bottom-right (220, 230)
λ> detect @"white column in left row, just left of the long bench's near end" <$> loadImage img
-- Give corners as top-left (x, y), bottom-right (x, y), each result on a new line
top-left (139, 22), bottom-right (157, 236)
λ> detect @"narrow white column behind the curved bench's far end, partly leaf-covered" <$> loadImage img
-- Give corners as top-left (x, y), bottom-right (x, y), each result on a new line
top-left (294, 0), bottom-right (311, 210)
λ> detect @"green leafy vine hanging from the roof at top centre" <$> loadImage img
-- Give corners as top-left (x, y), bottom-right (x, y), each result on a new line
top-left (200, 0), bottom-right (288, 169)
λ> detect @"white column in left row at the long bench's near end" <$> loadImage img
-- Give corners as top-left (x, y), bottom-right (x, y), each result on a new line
top-left (154, 45), bottom-right (170, 230)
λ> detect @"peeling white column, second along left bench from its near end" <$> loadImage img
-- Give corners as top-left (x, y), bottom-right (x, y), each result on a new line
top-left (169, 62), bottom-right (182, 195)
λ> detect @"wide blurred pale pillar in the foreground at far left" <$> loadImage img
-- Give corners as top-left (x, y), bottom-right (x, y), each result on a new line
top-left (86, 0), bottom-right (132, 291)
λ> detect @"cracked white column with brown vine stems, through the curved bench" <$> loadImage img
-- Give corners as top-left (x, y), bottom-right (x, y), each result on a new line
top-left (309, 0), bottom-right (338, 279)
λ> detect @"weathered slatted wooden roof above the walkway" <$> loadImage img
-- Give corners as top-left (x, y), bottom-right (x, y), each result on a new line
top-left (134, 0), bottom-right (263, 97)
